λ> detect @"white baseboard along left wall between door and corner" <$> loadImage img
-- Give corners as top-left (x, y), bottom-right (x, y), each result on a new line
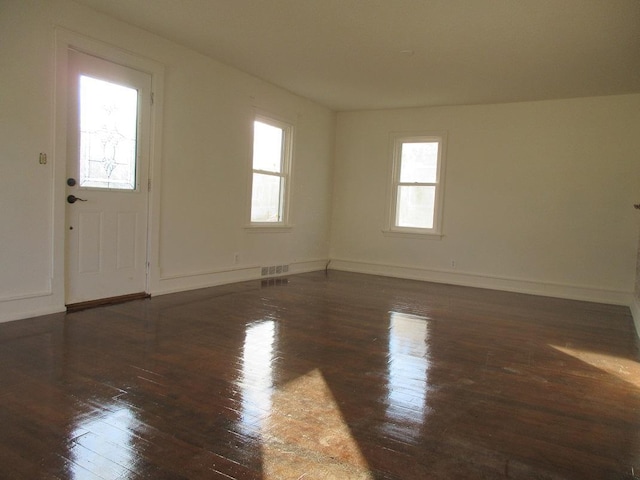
top-left (150, 259), bottom-right (329, 296)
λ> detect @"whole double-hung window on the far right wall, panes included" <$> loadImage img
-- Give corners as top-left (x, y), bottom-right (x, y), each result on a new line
top-left (388, 135), bottom-right (444, 235)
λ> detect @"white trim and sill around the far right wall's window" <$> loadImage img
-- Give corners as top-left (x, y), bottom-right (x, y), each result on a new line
top-left (382, 132), bottom-right (447, 239)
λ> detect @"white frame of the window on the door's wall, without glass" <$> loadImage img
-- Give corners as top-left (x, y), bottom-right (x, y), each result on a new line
top-left (247, 113), bottom-right (295, 232)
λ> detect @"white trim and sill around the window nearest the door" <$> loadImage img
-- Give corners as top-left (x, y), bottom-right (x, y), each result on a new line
top-left (245, 112), bottom-right (295, 233)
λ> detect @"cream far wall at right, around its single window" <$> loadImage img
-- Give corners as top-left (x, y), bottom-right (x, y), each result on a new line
top-left (331, 95), bottom-right (640, 305)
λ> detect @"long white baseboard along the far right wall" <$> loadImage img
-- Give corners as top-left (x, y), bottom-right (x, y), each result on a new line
top-left (329, 259), bottom-right (640, 306)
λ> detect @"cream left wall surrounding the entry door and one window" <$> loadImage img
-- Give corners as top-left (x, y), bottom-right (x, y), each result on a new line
top-left (0, 0), bottom-right (335, 321)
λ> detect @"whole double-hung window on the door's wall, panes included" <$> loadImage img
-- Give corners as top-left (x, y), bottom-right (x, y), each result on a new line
top-left (251, 116), bottom-right (293, 225)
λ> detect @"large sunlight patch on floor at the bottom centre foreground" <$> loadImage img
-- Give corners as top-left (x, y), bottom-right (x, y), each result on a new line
top-left (262, 369), bottom-right (374, 480)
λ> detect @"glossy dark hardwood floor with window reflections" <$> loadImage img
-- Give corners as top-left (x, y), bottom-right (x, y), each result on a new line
top-left (0, 271), bottom-right (640, 480)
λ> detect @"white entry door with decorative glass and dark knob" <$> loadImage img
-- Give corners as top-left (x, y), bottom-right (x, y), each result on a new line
top-left (65, 50), bottom-right (151, 305)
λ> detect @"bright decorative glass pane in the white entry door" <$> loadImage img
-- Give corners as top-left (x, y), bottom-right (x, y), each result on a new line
top-left (80, 75), bottom-right (138, 190)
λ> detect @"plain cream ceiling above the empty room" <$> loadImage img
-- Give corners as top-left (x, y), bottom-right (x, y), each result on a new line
top-left (70, 0), bottom-right (640, 111)
